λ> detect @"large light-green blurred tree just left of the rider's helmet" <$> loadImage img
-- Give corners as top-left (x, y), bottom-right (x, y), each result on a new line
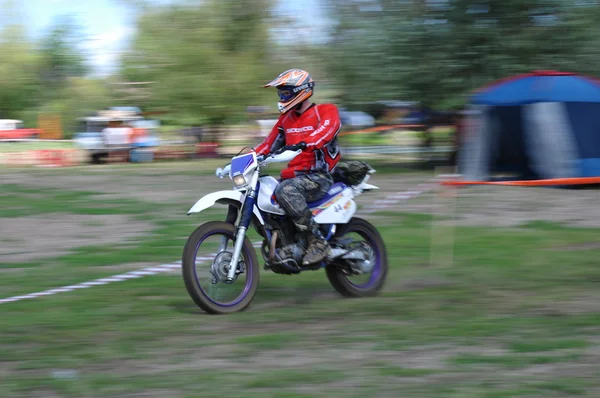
top-left (122, 0), bottom-right (273, 125)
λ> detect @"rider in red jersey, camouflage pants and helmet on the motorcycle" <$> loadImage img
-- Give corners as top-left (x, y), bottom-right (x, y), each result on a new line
top-left (255, 69), bottom-right (341, 265)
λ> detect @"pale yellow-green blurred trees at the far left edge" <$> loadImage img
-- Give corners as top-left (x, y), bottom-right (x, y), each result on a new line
top-left (0, 19), bottom-right (110, 132)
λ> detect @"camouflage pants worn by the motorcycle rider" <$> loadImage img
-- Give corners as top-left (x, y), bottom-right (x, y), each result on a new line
top-left (275, 172), bottom-right (333, 230)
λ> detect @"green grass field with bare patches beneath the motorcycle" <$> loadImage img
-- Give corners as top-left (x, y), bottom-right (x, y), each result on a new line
top-left (0, 162), bottom-right (600, 398)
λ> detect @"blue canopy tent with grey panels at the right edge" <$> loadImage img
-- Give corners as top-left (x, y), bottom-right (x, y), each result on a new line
top-left (459, 71), bottom-right (600, 181)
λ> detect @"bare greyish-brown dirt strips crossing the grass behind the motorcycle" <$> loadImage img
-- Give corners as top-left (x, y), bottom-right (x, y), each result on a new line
top-left (0, 163), bottom-right (600, 262)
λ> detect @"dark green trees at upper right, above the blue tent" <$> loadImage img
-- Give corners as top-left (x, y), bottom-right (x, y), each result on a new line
top-left (328, 0), bottom-right (600, 107)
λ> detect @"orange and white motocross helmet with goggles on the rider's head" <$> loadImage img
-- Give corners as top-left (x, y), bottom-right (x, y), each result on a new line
top-left (265, 69), bottom-right (315, 113)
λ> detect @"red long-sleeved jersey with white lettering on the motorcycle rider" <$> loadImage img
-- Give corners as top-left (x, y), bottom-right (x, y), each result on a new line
top-left (255, 104), bottom-right (342, 179)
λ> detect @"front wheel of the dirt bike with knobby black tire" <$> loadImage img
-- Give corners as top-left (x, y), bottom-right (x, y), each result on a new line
top-left (181, 221), bottom-right (260, 314)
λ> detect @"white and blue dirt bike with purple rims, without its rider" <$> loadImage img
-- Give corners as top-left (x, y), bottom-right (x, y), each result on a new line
top-left (182, 143), bottom-right (388, 314)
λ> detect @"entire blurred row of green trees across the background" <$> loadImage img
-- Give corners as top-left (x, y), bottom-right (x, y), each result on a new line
top-left (0, 0), bottom-right (600, 131)
